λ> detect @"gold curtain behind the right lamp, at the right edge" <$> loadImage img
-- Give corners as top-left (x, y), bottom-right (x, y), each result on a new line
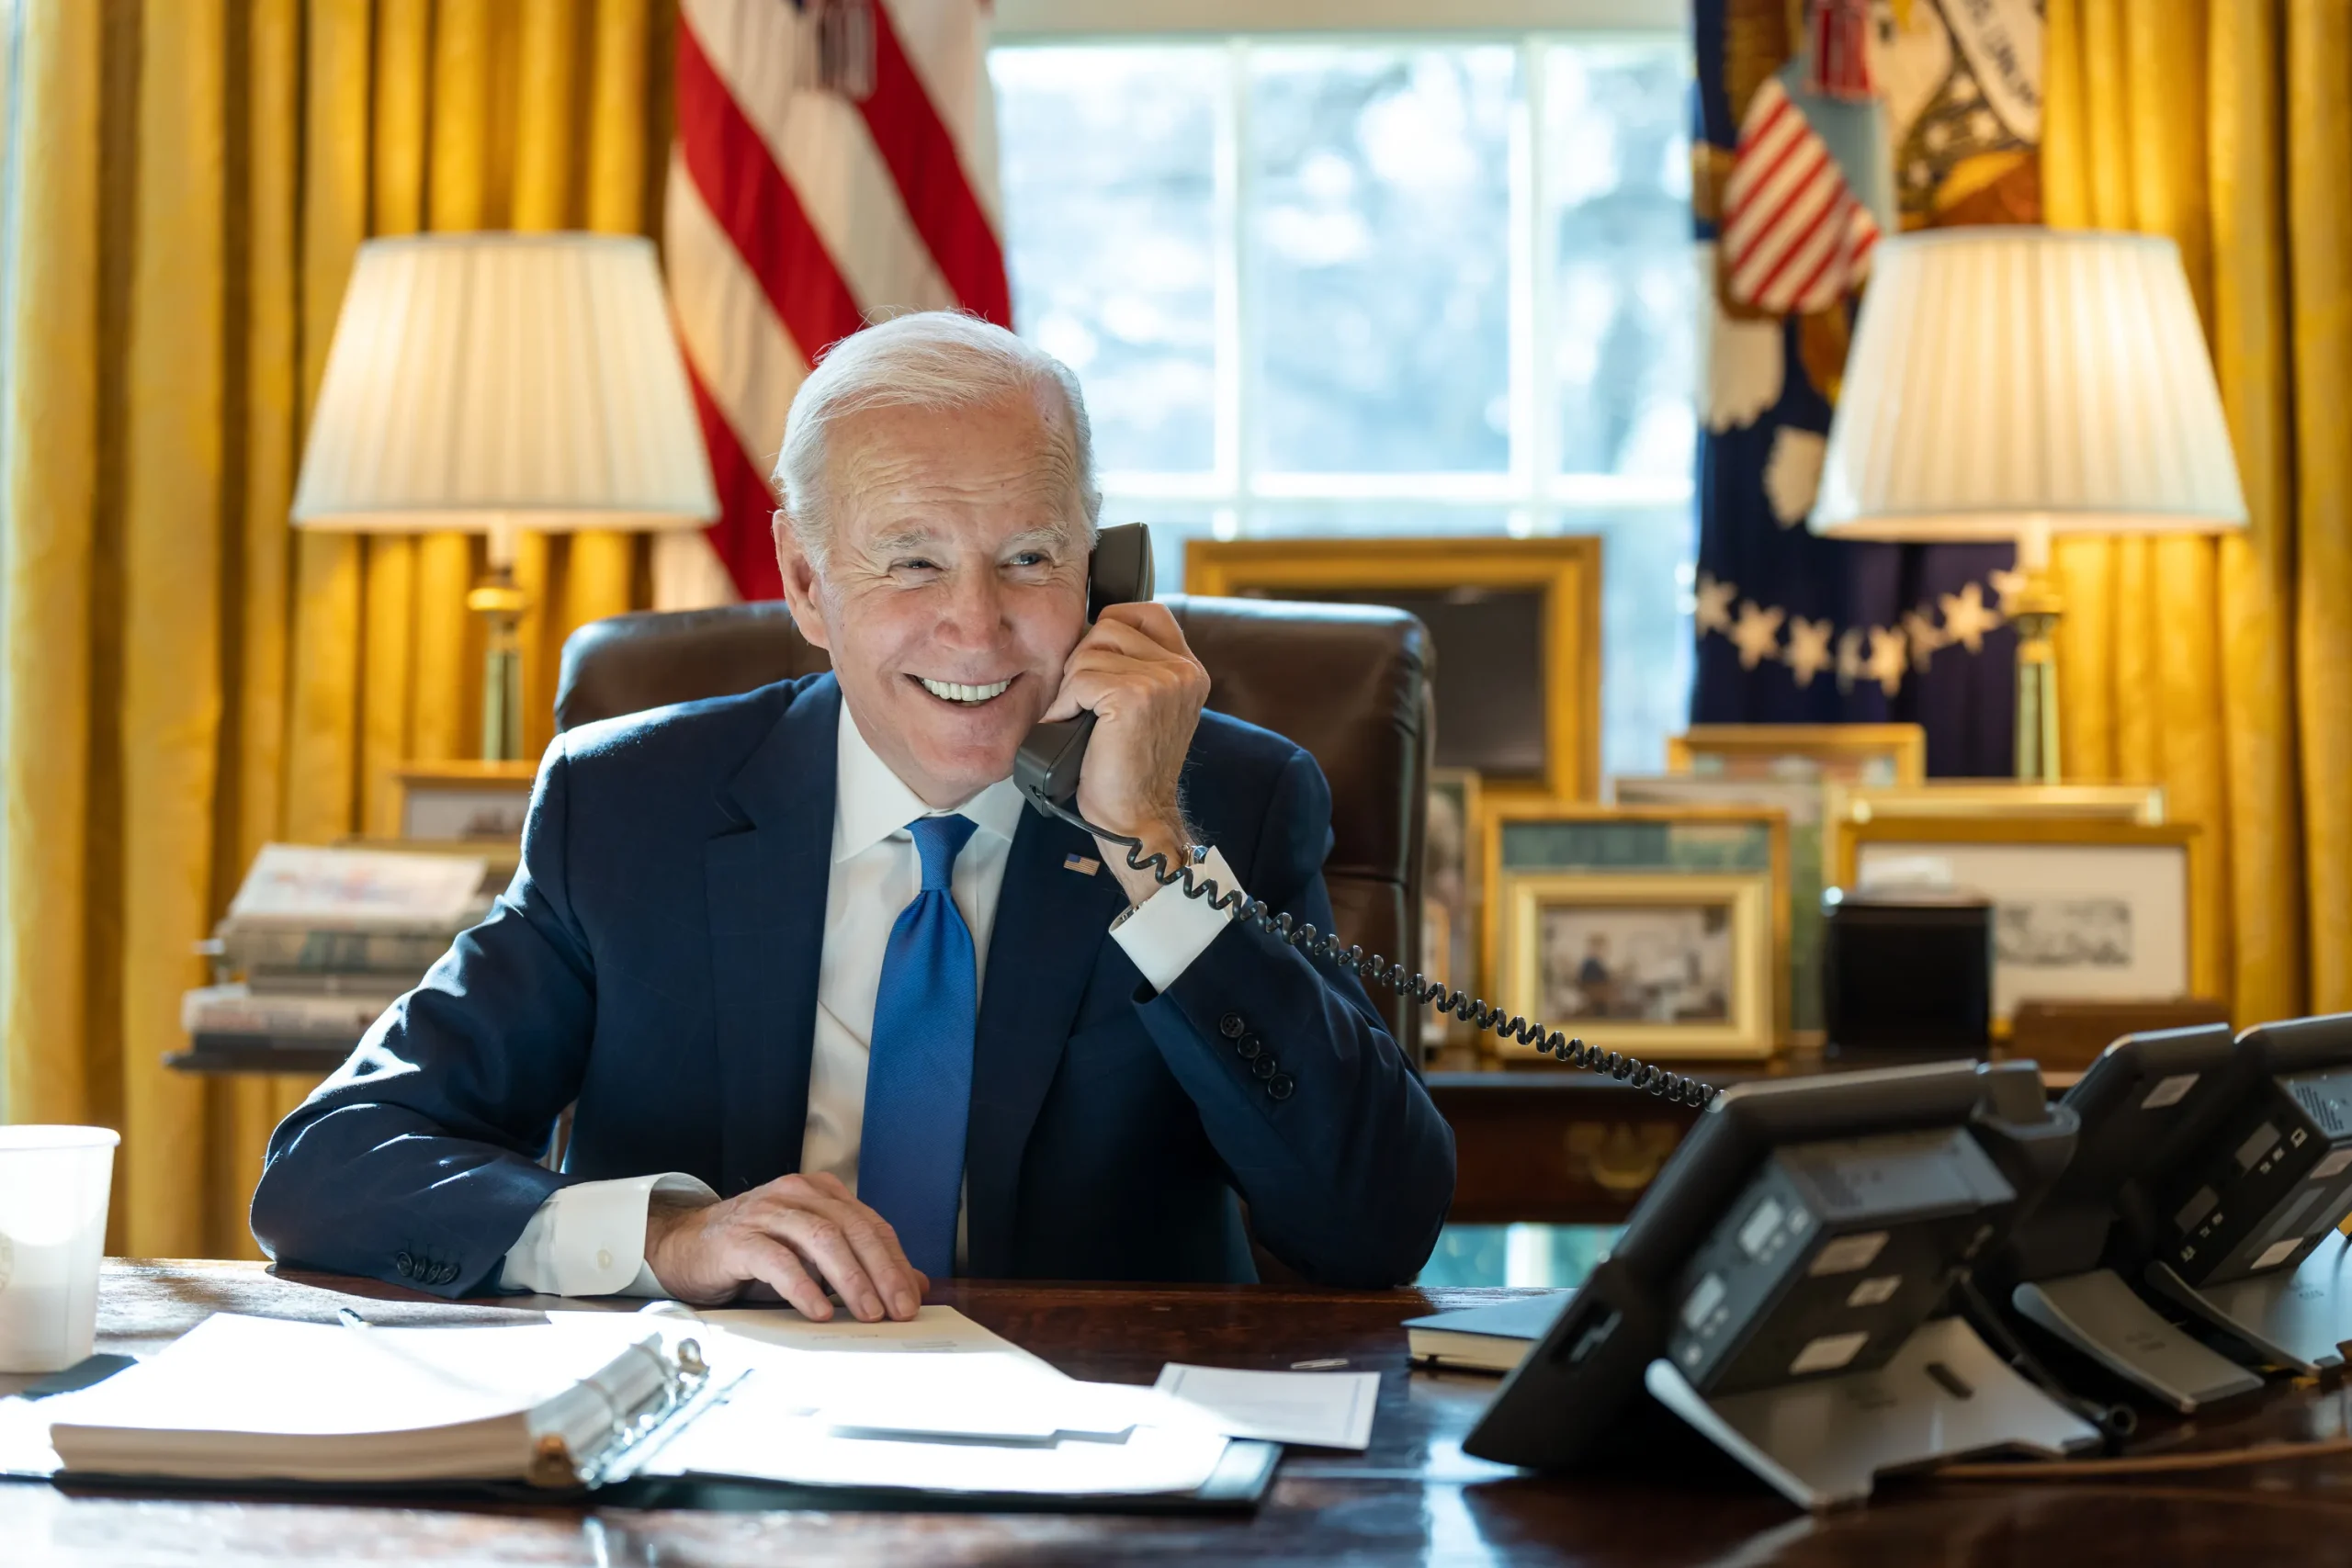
top-left (2041, 0), bottom-right (2352, 1022)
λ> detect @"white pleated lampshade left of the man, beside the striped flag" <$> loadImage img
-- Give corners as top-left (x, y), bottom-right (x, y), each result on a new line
top-left (294, 232), bottom-right (718, 536)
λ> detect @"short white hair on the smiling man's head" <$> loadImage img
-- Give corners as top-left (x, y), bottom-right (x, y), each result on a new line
top-left (772, 310), bottom-right (1103, 571)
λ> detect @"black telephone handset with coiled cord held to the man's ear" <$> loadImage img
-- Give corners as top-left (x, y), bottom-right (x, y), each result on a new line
top-left (1013, 522), bottom-right (1714, 1105)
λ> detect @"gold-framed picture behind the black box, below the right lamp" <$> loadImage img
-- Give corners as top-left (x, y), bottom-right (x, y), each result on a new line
top-left (1837, 816), bottom-right (2206, 1032)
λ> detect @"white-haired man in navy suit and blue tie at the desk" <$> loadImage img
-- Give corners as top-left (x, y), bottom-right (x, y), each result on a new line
top-left (254, 312), bottom-right (1453, 1319)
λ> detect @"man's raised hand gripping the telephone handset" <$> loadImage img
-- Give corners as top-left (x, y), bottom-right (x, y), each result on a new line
top-left (1042, 602), bottom-right (1209, 903)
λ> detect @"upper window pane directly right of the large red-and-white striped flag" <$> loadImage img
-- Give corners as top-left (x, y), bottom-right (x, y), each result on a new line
top-left (988, 47), bottom-right (1226, 472)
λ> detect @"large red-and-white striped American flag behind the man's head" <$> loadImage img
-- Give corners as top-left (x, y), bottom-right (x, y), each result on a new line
top-left (654, 0), bottom-right (1012, 609)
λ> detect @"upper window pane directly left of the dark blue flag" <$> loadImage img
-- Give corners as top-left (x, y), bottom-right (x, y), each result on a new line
top-left (1543, 42), bottom-right (1698, 479)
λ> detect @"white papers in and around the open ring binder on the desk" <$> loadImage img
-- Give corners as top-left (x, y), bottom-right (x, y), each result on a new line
top-left (0, 1307), bottom-right (1381, 1497)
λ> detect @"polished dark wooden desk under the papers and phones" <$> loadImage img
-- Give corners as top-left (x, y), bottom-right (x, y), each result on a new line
top-left (0, 1262), bottom-right (2352, 1568)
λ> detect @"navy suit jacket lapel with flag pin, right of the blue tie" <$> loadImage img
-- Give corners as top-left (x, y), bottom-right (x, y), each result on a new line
top-left (965, 811), bottom-right (1126, 1279)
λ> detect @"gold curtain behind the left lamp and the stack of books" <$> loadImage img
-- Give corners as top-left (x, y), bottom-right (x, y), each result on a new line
top-left (0, 0), bottom-right (671, 1256)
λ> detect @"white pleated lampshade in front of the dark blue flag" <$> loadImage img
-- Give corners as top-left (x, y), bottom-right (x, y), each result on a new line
top-left (1811, 226), bottom-right (2246, 547)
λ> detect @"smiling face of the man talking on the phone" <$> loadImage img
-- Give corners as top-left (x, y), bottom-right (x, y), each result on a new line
top-left (776, 398), bottom-right (1087, 807)
